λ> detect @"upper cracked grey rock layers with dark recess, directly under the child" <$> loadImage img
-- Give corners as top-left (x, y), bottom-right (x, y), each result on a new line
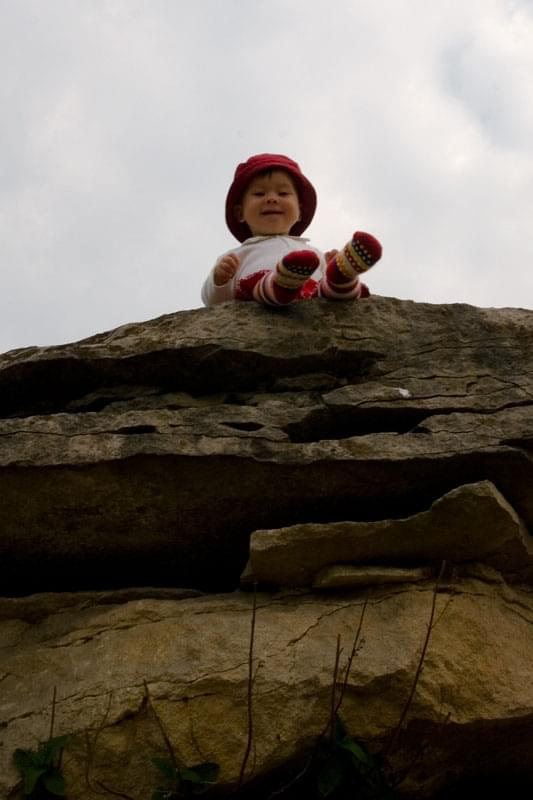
top-left (0, 297), bottom-right (533, 594)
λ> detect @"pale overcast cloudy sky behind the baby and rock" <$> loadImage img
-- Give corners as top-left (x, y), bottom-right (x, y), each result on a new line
top-left (0, 0), bottom-right (533, 352)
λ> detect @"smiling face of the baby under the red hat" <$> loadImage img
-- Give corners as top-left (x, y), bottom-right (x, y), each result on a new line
top-left (235, 169), bottom-right (300, 236)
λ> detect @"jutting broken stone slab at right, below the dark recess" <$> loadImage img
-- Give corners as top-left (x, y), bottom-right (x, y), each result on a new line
top-left (246, 481), bottom-right (533, 586)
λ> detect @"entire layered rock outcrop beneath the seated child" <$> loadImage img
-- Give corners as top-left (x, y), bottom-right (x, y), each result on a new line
top-left (0, 297), bottom-right (533, 800)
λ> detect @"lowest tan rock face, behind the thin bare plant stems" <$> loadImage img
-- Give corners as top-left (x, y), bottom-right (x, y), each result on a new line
top-left (0, 579), bottom-right (533, 800)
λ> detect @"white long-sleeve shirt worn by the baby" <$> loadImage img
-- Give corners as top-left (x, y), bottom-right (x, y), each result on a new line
top-left (202, 236), bottom-right (326, 306)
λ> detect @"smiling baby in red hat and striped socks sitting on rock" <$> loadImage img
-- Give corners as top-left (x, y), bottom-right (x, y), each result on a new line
top-left (202, 153), bottom-right (381, 306)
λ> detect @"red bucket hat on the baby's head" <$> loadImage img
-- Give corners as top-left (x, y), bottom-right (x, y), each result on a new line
top-left (226, 153), bottom-right (316, 242)
